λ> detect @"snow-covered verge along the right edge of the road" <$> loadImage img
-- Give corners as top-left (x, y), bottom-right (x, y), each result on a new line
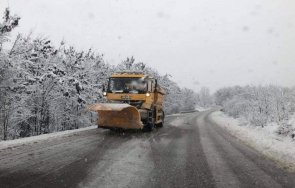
top-left (211, 111), bottom-right (295, 171)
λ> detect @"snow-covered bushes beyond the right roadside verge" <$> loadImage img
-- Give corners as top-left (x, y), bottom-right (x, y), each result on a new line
top-left (215, 85), bottom-right (295, 135)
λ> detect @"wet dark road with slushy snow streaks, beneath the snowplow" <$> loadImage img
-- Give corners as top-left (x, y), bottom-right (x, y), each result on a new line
top-left (0, 111), bottom-right (295, 188)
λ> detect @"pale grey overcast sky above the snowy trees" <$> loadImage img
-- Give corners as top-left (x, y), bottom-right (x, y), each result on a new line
top-left (0, 0), bottom-right (295, 90)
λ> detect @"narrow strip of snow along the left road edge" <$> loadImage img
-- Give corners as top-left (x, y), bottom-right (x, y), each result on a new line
top-left (0, 125), bottom-right (97, 149)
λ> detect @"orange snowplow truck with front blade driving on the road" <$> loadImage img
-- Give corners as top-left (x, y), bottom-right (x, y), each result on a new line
top-left (89, 72), bottom-right (165, 131)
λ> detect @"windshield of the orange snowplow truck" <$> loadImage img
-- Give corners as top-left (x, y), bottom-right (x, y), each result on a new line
top-left (108, 78), bottom-right (147, 93)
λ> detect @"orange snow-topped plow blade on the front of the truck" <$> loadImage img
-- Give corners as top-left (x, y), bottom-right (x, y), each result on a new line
top-left (88, 103), bottom-right (143, 129)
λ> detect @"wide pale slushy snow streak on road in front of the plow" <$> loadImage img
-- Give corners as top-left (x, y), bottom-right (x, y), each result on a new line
top-left (78, 138), bottom-right (154, 188)
